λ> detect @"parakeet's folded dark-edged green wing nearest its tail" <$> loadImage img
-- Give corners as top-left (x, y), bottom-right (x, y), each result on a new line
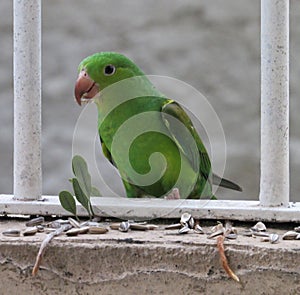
top-left (162, 100), bottom-right (212, 183)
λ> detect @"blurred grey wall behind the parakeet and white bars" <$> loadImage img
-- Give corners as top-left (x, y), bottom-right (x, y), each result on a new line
top-left (0, 0), bottom-right (300, 201)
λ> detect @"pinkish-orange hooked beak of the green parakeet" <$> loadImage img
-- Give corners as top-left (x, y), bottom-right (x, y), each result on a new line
top-left (74, 70), bottom-right (100, 105)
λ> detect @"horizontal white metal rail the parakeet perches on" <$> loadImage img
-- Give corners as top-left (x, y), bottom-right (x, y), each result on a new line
top-left (0, 195), bottom-right (300, 222)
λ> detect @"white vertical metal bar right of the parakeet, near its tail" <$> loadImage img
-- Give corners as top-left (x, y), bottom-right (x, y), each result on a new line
top-left (259, 0), bottom-right (289, 206)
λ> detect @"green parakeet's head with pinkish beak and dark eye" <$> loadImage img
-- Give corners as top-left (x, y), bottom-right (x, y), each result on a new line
top-left (75, 52), bottom-right (144, 105)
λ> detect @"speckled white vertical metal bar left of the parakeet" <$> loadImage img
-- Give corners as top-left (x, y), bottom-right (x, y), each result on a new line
top-left (14, 0), bottom-right (42, 200)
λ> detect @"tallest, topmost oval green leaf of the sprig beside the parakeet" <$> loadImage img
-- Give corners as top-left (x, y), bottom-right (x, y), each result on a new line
top-left (72, 155), bottom-right (92, 198)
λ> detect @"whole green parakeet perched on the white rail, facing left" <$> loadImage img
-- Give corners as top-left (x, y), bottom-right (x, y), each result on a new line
top-left (75, 52), bottom-right (241, 198)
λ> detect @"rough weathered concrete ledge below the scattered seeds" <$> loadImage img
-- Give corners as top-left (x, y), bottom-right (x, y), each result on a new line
top-left (0, 220), bottom-right (300, 295)
